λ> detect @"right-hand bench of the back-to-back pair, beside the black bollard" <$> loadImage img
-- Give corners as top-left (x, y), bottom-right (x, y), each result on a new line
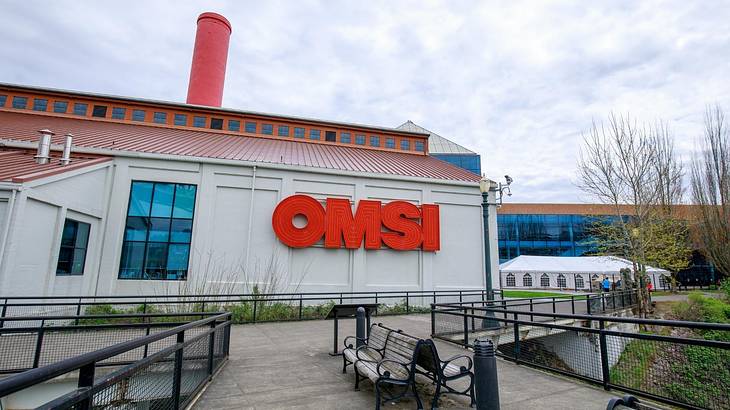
top-left (416, 339), bottom-right (476, 408)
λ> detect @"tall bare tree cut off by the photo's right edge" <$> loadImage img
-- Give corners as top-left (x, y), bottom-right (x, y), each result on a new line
top-left (691, 106), bottom-right (730, 277)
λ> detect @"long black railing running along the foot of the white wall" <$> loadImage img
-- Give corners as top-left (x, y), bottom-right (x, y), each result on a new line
top-left (0, 289), bottom-right (500, 328)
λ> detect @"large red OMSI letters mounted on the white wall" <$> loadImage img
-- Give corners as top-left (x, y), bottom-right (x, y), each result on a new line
top-left (271, 195), bottom-right (441, 251)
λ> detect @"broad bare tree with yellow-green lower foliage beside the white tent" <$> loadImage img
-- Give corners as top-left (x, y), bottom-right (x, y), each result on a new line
top-left (578, 114), bottom-right (689, 313)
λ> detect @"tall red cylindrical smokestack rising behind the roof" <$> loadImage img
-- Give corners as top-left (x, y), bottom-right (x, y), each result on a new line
top-left (187, 13), bottom-right (231, 107)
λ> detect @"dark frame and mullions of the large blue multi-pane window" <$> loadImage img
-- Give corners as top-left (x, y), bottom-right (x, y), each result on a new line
top-left (117, 179), bottom-right (199, 281)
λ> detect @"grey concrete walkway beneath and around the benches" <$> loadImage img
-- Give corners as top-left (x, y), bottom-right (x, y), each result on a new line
top-left (195, 315), bottom-right (620, 409)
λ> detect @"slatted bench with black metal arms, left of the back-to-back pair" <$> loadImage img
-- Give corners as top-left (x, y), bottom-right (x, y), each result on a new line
top-left (342, 323), bottom-right (424, 409)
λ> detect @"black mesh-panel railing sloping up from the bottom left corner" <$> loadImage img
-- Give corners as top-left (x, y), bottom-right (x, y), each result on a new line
top-left (0, 313), bottom-right (231, 409)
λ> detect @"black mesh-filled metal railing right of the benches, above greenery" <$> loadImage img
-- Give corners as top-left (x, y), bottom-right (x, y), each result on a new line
top-left (431, 295), bottom-right (730, 409)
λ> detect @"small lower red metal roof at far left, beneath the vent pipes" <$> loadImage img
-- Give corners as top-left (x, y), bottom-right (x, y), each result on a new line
top-left (0, 148), bottom-right (112, 183)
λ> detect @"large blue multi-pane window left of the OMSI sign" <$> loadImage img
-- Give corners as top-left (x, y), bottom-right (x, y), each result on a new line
top-left (119, 181), bottom-right (197, 280)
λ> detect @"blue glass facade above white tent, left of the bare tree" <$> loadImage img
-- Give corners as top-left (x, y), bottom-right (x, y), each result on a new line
top-left (497, 214), bottom-right (599, 263)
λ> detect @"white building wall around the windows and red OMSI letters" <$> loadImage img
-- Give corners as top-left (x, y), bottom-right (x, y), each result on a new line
top-left (0, 157), bottom-right (499, 295)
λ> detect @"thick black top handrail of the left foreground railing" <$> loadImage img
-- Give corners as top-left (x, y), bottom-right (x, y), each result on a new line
top-left (0, 313), bottom-right (231, 397)
